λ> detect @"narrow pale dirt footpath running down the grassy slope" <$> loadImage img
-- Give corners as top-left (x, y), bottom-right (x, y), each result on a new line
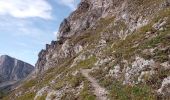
top-left (81, 69), bottom-right (108, 100)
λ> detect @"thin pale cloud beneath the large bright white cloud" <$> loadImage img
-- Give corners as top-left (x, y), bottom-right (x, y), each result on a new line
top-left (0, 16), bottom-right (39, 37)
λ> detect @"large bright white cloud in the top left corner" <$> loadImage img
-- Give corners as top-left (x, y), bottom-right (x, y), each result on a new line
top-left (0, 0), bottom-right (52, 19)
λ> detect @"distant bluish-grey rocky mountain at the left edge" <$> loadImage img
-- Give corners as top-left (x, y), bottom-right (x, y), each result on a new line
top-left (0, 55), bottom-right (34, 84)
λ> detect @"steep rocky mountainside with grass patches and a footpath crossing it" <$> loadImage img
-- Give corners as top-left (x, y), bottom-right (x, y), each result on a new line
top-left (4, 0), bottom-right (170, 100)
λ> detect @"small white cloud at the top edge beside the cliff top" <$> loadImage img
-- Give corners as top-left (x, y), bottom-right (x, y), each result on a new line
top-left (57, 0), bottom-right (76, 10)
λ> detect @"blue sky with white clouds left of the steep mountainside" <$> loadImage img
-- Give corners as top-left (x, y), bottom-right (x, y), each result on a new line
top-left (0, 0), bottom-right (80, 65)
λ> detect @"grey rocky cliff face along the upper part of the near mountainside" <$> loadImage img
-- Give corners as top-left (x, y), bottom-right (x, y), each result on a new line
top-left (36, 0), bottom-right (170, 73)
